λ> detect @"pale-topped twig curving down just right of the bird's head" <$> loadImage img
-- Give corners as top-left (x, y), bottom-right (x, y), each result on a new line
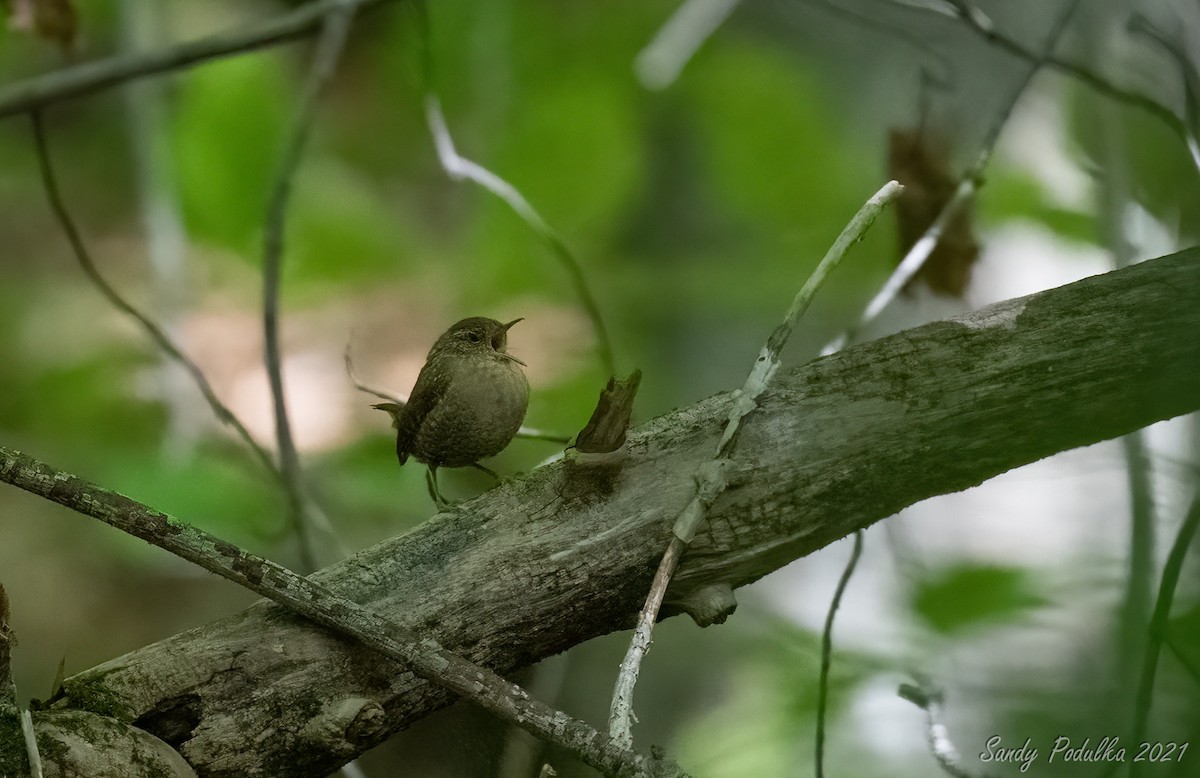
top-left (425, 93), bottom-right (617, 376)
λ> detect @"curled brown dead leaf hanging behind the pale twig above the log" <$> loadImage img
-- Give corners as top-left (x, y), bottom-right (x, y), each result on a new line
top-left (888, 128), bottom-right (979, 297)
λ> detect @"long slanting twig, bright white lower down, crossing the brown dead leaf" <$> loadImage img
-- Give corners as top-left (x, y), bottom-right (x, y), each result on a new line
top-left (821, 0), bottom-right (1079, 357)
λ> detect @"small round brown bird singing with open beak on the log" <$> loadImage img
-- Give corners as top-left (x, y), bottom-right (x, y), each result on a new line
top-left (372, 316), bottom-right (529, 508)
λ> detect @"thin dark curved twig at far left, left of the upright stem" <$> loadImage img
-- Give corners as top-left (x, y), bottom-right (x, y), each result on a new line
top-left (29, 110), bottom-right (280, 478)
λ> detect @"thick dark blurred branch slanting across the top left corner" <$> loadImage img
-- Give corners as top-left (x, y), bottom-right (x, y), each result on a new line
top-left (0, 0), bottom-right (396, 119)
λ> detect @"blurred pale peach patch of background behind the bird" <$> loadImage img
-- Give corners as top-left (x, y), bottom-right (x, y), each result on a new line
top-left (157, 287), bottom-right (594, 451)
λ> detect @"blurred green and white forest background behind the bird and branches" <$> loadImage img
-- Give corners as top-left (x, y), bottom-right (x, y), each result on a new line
top-left (0, 0), bottom-right (1200, 778)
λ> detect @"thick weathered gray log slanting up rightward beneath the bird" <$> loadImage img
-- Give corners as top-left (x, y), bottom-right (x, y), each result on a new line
top-left (37, 250), bottom-right (1200, 776)
